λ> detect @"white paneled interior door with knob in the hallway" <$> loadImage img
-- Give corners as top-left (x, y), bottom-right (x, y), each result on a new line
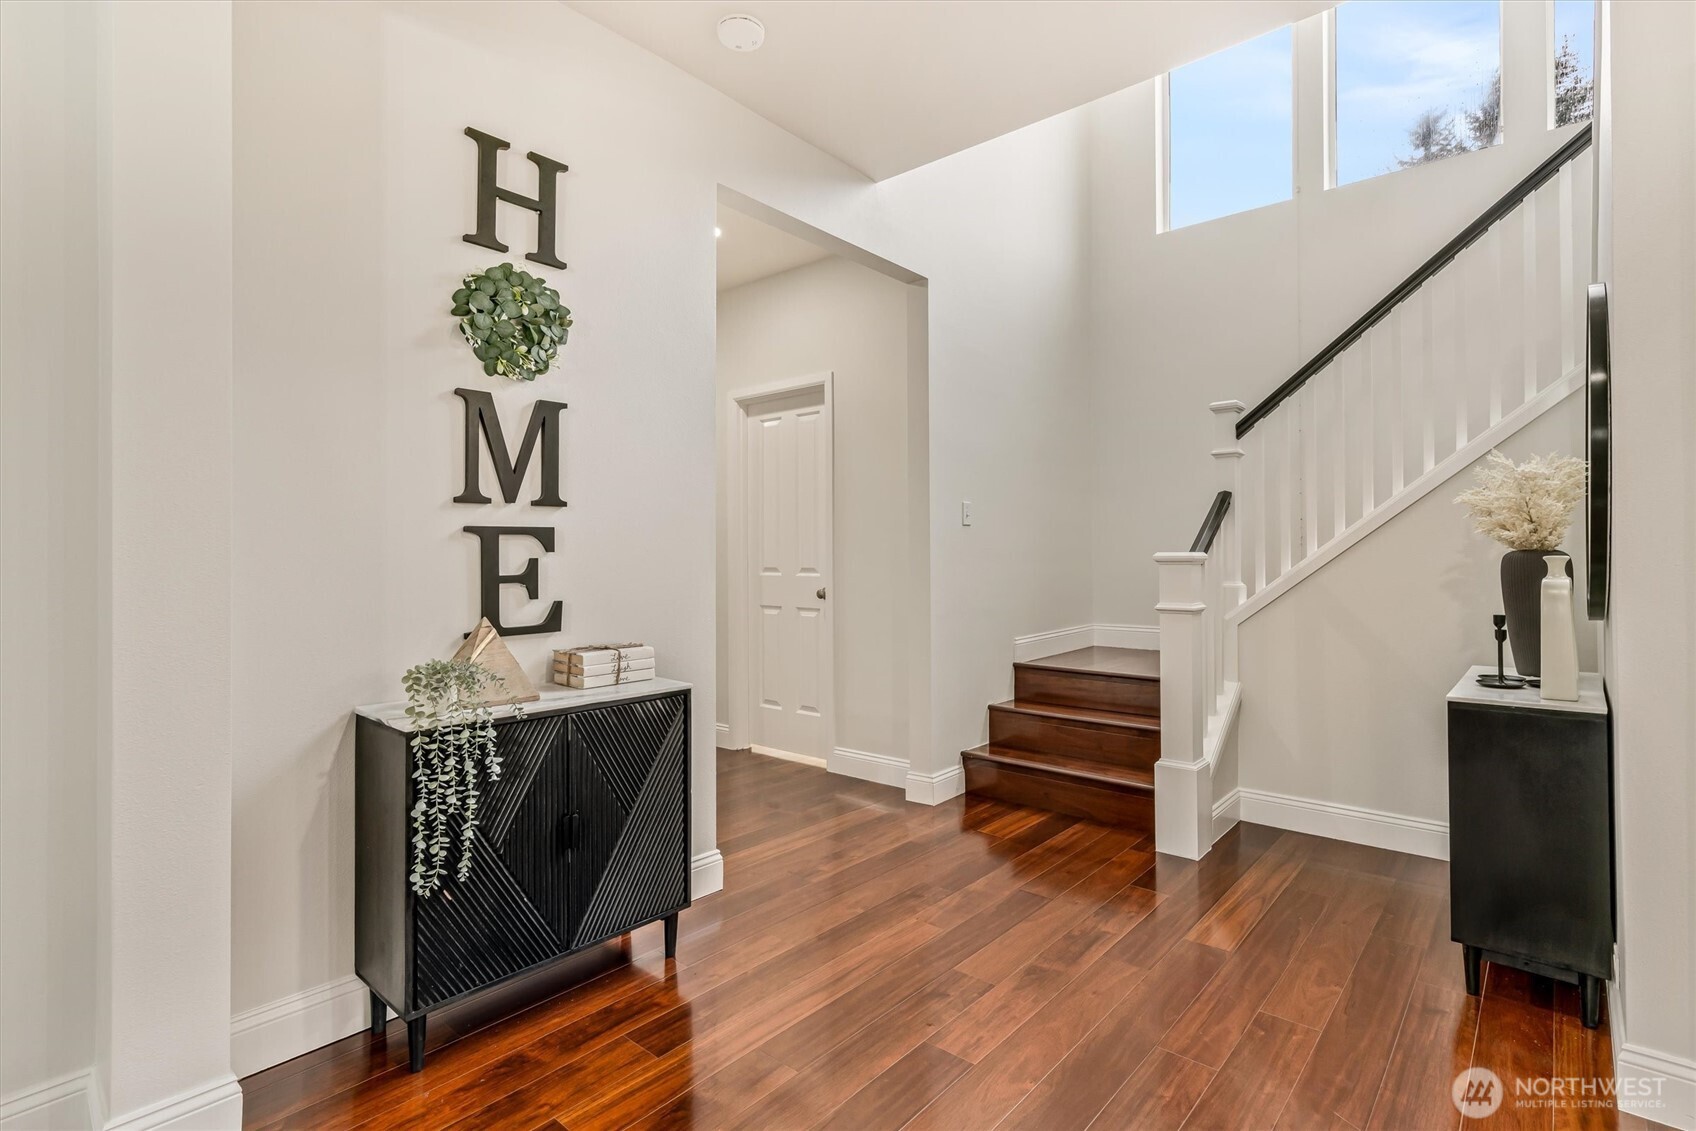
top-left (743, 385), bottom-right (831, 761)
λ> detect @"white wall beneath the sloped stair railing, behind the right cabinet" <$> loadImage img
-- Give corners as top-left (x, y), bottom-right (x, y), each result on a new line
top-left (1236, 405), bottom-right (1598, 851)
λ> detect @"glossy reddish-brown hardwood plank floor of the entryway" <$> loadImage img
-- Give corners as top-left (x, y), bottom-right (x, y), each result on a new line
top-left (243, 751), bottom-right (1652, 1131)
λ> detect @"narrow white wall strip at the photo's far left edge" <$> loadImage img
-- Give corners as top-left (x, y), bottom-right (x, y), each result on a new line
top-left (0, 3), bottom-right (98, 1123)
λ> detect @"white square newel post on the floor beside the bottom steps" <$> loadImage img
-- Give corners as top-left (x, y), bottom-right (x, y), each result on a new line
top-left (1155, 553), bottom-right (1213, 860)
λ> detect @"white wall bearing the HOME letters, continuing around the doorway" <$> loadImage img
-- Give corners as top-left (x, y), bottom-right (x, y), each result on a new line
top-left (231, 3), bottom-right (1089, 1068)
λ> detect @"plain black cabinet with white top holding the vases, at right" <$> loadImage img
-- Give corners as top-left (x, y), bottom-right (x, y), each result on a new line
top-left (1448, 668), bottom-right (1613, 1029)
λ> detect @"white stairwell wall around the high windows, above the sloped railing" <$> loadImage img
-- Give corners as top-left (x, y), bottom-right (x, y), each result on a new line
top-left (1085, 3), bottom-right (1574, 627)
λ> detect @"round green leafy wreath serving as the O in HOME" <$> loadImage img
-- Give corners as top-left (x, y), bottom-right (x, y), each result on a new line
top-left (453, 263), bottom-right (572, 382)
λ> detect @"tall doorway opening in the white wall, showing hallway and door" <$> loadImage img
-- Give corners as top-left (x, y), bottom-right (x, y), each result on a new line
top-left (716, 190), bottom-right (929, 788)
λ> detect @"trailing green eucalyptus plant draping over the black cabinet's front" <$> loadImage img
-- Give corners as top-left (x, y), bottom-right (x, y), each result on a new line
top-left (400, 660), bottom-right (522, 899)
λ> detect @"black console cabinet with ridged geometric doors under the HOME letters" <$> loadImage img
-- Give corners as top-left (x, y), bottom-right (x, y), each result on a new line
top-left (354, 682), bottom-right (690, 1072)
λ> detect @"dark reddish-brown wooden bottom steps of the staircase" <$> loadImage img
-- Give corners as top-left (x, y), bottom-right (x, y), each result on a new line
top-left (960, 648), bottom-right (1160, 831)
